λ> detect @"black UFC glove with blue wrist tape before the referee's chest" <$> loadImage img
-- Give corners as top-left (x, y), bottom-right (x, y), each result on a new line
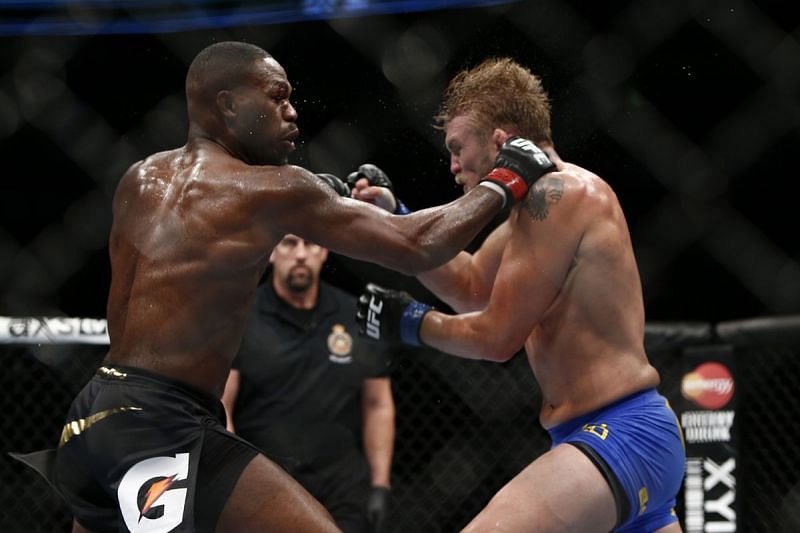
top-left (356, 283), bottom-right (433, 346)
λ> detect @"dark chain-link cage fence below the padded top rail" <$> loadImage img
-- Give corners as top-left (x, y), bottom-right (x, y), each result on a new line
top-left (0, 316), bottom-right (800, 533)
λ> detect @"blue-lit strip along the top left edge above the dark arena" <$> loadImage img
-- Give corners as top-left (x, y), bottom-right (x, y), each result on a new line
top-left (0, 0), bottom-right (519, 36)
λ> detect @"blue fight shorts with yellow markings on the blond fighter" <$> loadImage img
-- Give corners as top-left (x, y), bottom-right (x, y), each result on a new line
top-left (548, 389), bottom-right (686, 532)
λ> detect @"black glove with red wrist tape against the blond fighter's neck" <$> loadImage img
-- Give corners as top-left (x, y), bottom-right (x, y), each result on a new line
top-left (479, 136), bottom-right (556, 207)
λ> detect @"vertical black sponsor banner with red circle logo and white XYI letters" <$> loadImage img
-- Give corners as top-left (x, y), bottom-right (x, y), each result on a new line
top-left (678, 345), bottom-right (738, 533)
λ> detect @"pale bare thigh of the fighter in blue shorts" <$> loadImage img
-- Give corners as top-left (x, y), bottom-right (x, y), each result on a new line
top-left (464, 444), bottom-right (616, 533)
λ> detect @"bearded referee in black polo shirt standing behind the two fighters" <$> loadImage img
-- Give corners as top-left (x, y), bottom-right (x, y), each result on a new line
top-left (222, 234), bottom-right (395, 533)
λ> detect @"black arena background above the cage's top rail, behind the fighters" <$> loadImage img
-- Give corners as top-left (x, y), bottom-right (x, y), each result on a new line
top-left (0, 0), bottom-right (800, 322)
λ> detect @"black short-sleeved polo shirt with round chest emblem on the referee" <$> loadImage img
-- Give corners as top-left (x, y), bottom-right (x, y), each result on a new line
top-left (233, 279), bottom-right (388, 470)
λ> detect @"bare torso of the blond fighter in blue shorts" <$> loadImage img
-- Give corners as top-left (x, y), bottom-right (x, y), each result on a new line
top-left (503, 164), bottom-right (659, 428)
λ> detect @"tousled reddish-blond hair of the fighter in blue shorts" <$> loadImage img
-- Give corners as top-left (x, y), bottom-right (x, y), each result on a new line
top-left (434, 57), bottom-right (552, 143)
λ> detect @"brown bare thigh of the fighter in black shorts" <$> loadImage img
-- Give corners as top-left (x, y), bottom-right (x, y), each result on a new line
top-left (217, 455), bottom-right (339, 533)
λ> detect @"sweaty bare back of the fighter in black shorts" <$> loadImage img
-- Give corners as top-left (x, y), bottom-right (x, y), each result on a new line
top-left (107, 141), bottom-right (276, 394)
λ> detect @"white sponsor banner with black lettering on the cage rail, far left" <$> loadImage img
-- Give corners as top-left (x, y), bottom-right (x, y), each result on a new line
top-left (0, 316), bottom-right (109, 344)
